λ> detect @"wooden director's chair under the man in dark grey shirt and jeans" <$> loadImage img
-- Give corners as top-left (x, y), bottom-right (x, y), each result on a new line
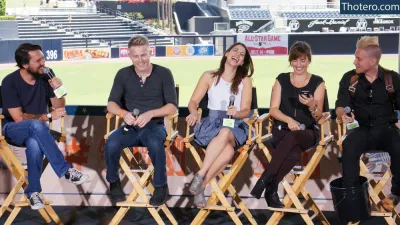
top-left (104, 85), bottom-right (179, 225)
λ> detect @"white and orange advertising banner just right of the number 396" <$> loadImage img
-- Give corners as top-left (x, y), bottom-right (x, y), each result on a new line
top-left (63, 48), bottom-right (111, 60)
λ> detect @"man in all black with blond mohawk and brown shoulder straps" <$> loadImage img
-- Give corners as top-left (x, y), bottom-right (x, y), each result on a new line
top-left (336, 36), bottom-right (400, 212)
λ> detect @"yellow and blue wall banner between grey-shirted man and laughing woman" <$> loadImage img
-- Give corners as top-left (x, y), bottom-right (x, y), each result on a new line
top-left (167, 45), bottom-right (214, 56)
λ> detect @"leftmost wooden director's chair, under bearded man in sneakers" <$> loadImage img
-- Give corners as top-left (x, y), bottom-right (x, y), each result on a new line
top-left (0, 87), bottom-right (66, 225)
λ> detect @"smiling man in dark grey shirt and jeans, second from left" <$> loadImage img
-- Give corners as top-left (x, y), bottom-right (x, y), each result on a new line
top-left (104, 35), bottom-right (178, 206)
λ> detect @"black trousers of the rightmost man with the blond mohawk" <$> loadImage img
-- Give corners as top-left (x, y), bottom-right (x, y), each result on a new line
top-left (342, 125), bottom-right (400, 195)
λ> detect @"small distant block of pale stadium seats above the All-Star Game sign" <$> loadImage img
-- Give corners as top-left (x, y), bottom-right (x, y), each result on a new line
top-left (228, 5), bottom-right (272, 20)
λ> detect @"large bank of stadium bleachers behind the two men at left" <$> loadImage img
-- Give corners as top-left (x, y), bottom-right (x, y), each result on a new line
top-left (18, 13), bottom-right (172, 48)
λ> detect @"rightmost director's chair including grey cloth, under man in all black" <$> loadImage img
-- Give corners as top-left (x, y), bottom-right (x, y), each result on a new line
top-left (336, 120), bottom-right (400, 225)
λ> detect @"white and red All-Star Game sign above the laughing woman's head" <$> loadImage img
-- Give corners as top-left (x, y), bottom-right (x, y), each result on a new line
top-left (237, 33), bottom-right (289, 56)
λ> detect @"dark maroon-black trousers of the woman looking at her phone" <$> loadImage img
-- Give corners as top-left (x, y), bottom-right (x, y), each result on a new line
top-left (266, 128), bottom-right (319, 189)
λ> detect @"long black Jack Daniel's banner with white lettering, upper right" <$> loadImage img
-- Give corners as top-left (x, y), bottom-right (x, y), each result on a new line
top-left (287, 17), bottom-right (399, 32)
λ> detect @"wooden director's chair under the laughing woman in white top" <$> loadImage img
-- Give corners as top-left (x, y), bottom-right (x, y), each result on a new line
top-left (184, 87), bottom-right (258, 225)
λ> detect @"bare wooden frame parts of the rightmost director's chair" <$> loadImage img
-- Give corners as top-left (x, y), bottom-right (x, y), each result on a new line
top-left (336, 120), bottom-right (400, 225)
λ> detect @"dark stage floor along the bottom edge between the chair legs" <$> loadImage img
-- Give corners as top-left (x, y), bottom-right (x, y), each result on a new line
top-left (0, 206), bottom-right (386, 225)
